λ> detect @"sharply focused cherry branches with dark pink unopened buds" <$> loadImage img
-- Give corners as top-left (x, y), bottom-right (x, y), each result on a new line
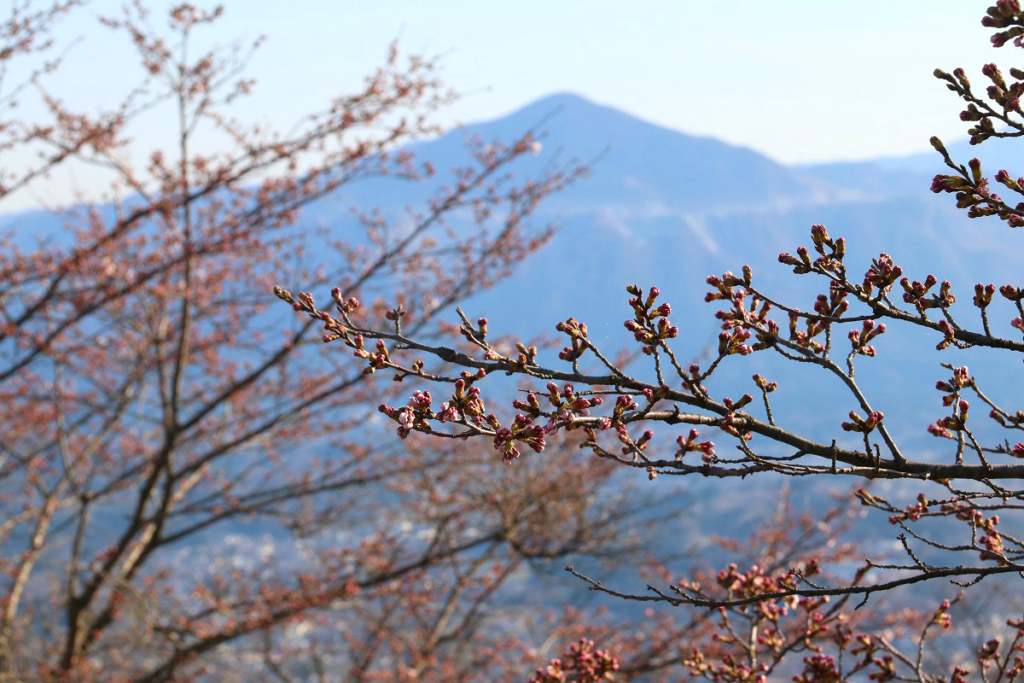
top-left (275, 0), bottom-right (1024, 681)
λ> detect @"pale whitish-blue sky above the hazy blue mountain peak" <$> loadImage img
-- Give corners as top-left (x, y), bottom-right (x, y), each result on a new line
top-left (8, 0), bottom-right (1011, 209)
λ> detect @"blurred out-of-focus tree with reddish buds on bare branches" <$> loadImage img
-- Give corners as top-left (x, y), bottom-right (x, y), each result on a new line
top-left (0, 0), bottom-right (679, 682)
